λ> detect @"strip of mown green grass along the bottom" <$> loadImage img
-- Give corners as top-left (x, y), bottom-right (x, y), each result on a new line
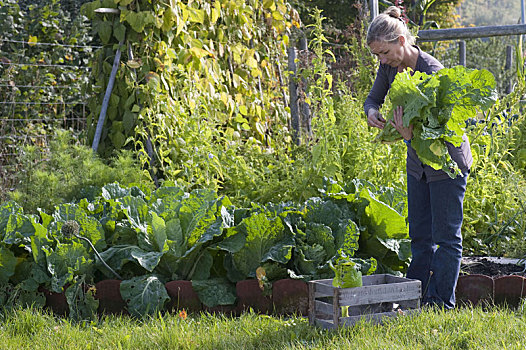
top-left (0, 307), bottom-right (526, 350)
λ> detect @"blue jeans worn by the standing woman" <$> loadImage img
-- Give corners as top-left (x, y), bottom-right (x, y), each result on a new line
top-left (407, 174), bottom-right (467, 309)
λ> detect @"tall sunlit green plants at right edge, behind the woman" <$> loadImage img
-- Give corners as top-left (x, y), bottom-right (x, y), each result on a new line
top-left (464, 45), bottom-right (526, 257)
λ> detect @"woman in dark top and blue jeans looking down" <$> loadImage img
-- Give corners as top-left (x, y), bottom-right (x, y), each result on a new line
top-left (364, 6), bottom-right (473, 309)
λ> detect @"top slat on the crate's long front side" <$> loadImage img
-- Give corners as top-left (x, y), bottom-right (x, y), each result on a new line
top-left (338, 281), bottom-right (421, 306)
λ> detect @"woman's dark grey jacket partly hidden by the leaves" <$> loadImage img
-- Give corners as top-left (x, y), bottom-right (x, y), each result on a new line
top-left (364, 46), bottom-right (473, 182)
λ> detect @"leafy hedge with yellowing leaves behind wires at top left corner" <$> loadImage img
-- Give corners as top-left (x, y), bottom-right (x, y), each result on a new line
top-left (0, 0), bottom-right (91, 125)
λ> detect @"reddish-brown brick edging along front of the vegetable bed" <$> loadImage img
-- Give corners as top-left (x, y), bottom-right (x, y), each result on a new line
top-left (40, 274), bottom-right (526, 316)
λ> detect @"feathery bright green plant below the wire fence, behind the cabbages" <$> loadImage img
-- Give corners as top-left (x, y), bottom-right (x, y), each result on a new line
top-left (9, 130), bottom-right (149, 213)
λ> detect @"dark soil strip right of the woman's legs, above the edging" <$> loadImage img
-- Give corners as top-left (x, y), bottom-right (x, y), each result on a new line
top-left (460, 257), bottom-right (525, 277)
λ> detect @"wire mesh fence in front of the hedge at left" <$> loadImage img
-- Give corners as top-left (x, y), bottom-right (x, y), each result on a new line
top-left (0, 39), bottom-right (99, 200)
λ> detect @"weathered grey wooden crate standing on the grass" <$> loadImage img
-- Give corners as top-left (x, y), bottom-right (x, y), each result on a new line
top-left (309, 274), bottom-right (422, 328)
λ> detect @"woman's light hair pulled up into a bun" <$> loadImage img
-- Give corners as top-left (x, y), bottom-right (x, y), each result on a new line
top-left (367, 6), bottom-right (415, 45)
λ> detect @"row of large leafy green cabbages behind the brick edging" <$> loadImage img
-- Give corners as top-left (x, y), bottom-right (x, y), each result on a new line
top-left (0, 180), bottom-right (410, 316)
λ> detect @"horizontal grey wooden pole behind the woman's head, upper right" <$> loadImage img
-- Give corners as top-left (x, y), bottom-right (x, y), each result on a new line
top-left (418, 24), bottom-right (526, 42)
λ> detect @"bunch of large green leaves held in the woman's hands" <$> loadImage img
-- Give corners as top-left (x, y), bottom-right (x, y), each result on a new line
top-left (376, 66), bottom-right (497, 178)
